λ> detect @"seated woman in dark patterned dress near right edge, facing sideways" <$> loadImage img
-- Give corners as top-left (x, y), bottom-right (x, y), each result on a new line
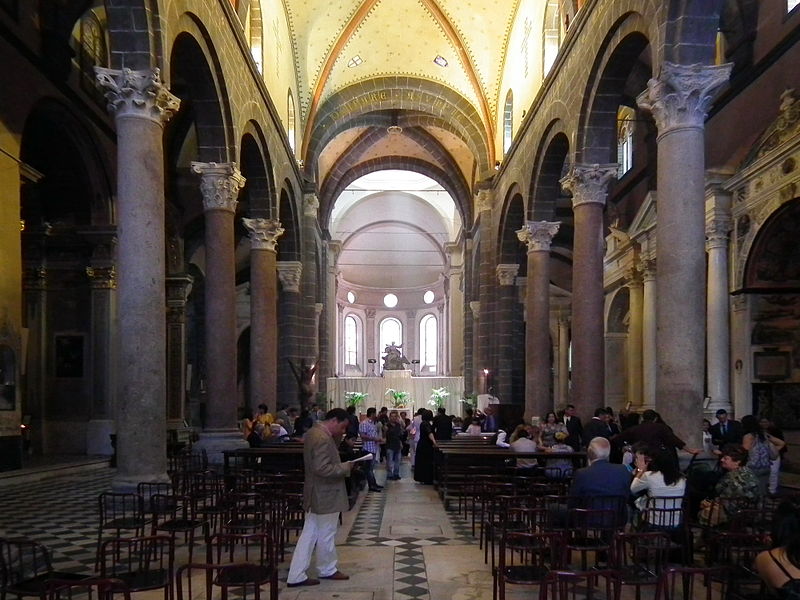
top-left (699, 444), bottom-right (761, 525)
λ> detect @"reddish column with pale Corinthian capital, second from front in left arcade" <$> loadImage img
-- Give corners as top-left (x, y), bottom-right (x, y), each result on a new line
top-left (192, 162), bottom-right (245, 463)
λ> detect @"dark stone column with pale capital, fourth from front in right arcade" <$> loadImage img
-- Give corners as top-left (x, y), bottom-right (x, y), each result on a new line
top-left (493, 264), bottom-right (519, 402)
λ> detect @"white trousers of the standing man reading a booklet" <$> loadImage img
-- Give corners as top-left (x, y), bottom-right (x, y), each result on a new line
top-left (286, 512), bottom-right (339, 583)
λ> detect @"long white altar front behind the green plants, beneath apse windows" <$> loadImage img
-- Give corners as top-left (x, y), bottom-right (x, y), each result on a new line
top-left (328, 369), bottom-right (464, 417)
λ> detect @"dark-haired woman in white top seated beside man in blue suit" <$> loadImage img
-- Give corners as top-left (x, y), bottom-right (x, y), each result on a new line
top-left (631, 448), bottom-right (686, 529)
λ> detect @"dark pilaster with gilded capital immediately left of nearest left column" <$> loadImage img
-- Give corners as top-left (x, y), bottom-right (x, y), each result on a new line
top-left (86, 265), bottom-right (117, 456)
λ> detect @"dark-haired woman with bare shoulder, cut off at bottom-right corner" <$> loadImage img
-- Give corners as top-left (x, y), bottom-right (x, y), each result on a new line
top-left (755, 500), bottom-right (800, 600)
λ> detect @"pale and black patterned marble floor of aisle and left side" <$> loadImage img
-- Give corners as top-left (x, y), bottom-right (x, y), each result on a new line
top-left (0, 464), bottom-right (736, 600)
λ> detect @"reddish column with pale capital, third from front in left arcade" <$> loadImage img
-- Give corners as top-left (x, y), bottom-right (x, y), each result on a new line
top-left (242, 218), bottom-right (284, 414)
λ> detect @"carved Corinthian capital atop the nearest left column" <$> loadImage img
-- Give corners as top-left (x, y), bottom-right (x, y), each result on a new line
top-left (94, 67), bottom-right (181, 125)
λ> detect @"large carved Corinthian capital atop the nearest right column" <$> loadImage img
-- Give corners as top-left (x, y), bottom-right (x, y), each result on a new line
top-left (636, 62), bottom-right (733, 137)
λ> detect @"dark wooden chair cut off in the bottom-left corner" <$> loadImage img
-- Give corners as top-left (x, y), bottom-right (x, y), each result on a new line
top-left (0, 538), bottom-right (90, 600)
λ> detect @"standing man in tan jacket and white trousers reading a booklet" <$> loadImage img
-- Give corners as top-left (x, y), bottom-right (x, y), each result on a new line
top-left (286, 408), bottom-right (353, 587)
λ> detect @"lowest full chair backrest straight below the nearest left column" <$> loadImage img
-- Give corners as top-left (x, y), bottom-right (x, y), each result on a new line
top-left (100, 535), bottom-right (175, 591)
